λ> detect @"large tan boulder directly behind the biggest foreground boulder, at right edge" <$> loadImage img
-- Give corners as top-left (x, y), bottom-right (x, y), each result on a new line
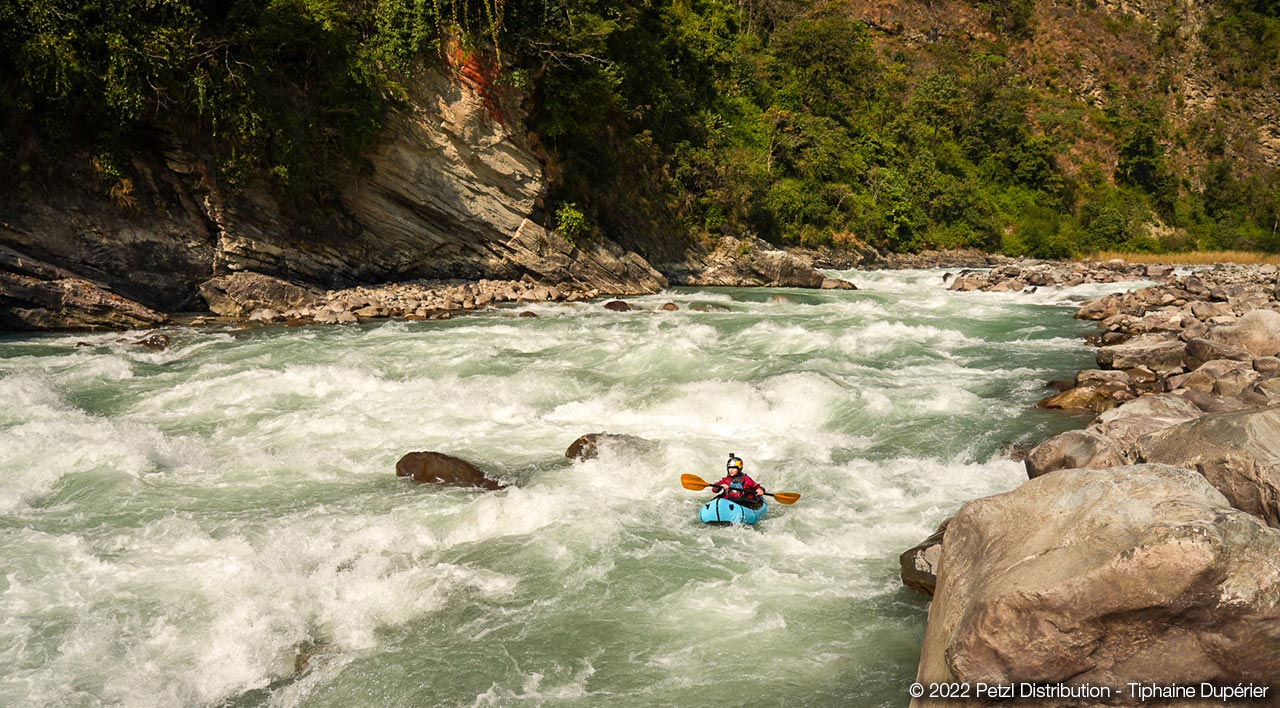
top-left (1135, 406), bottom-right (1280, 526)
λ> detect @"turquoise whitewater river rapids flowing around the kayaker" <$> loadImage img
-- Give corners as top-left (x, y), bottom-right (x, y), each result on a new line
top-left (0, 270), bottom-right (1121, 708)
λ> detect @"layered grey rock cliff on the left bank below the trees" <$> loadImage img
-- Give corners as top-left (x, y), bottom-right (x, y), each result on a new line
top-left (0, 62), bottom-right (666, 328)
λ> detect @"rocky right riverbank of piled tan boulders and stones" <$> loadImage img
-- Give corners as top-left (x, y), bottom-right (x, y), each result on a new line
top-left (902, 262), bottom-right (1280, 705)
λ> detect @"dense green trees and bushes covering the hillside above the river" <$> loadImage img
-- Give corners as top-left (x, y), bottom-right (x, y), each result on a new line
top-left (0, 0), bottom-right (1280, 256)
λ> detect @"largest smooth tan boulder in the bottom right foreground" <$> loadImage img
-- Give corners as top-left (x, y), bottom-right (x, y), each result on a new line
top-left (911, 465), bottom-right (1280, 707)
